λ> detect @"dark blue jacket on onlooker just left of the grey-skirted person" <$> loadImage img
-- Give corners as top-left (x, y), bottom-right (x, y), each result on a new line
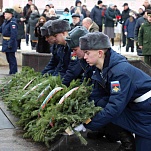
top-left (90, 6), bottom-right (103, 26)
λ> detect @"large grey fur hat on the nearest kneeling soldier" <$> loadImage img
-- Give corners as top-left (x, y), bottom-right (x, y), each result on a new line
top-left (80, 32), bottom-right (111, 50)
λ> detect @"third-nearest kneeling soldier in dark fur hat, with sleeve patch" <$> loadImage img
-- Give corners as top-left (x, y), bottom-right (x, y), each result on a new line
top-left (48, 19), bottom-right (85, 86)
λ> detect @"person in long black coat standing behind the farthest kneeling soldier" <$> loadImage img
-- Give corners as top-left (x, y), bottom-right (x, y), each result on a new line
top-left (35, 16), bottom-right (50, 53)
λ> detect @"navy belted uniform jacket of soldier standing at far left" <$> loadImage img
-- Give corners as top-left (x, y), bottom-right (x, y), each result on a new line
top-left (0, 17), bottom-right (18, 52)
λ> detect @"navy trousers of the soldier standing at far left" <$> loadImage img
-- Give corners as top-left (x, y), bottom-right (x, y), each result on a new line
top-left (6, 52), bottom-right (17, 74)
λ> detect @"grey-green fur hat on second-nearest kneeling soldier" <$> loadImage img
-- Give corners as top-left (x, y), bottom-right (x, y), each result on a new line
top-left (65, 26), bottom-right (88, 48)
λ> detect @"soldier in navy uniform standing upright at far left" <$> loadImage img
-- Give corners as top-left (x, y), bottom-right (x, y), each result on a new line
top-left (0, 8), bottom-right (18, 74)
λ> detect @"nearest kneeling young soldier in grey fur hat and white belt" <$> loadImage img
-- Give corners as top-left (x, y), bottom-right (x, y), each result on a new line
top-left (77, 32), bottom-right (151, 151)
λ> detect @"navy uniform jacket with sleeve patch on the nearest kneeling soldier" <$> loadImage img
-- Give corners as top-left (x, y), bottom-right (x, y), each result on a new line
top-left (84, 49), bottom-right (151, 139)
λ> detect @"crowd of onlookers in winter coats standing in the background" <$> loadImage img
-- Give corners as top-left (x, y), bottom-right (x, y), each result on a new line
top-left (0, 0), bottom-right (151, 52)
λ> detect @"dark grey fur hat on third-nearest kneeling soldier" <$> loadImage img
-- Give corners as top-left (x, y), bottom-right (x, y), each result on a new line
top-left (52, 19), bottom-right (71, 34)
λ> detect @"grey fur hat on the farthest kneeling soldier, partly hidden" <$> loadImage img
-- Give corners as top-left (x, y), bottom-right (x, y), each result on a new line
top-left (40, 20), bottom-right (52, 36)
